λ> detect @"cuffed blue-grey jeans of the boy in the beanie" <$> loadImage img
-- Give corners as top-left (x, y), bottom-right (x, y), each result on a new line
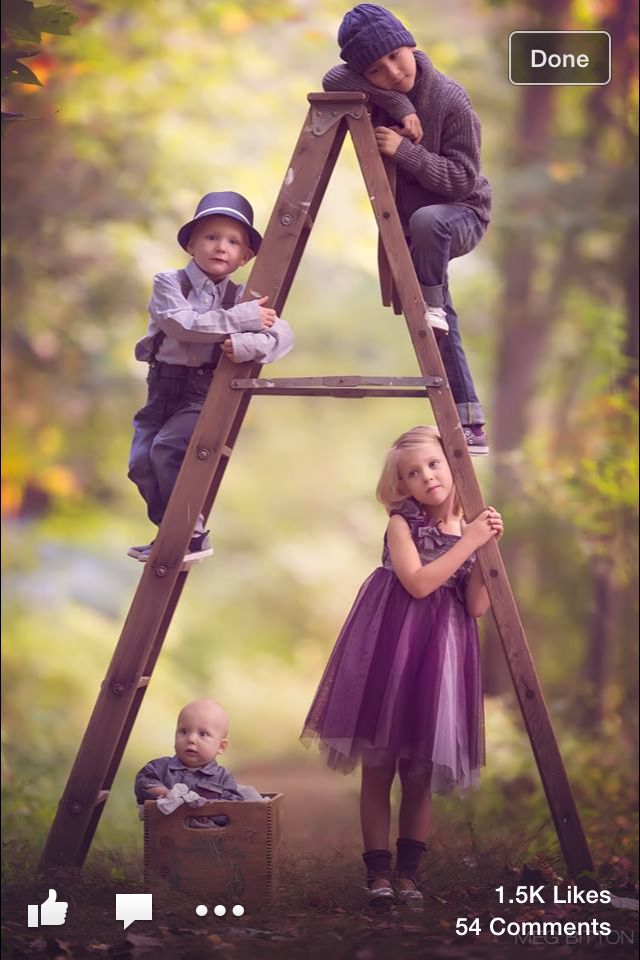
top-left (409, 203), bottom-right (487, 426)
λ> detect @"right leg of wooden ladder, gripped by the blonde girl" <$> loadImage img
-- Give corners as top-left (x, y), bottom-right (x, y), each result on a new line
top-left (347, 109), bottom-right (593, 877)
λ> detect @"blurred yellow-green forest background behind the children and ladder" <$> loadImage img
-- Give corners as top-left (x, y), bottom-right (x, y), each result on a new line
top-left (2, 0), bottom-right (638, 876)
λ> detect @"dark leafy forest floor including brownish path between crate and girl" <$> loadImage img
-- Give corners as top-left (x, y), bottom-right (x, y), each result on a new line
top-left (2, 766), bottom-right (638, 960)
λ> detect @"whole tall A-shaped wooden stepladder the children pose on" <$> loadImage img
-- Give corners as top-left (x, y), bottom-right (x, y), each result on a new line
top-left (42, 93), bottom-right (593, 883)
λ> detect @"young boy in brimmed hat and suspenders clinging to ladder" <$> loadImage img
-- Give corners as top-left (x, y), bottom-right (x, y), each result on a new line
top-left (128, 191), bottom-right (293, 562)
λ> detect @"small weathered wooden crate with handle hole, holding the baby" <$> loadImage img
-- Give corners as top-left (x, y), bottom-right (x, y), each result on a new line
top-left (144, 793), bottom-right (283, 909)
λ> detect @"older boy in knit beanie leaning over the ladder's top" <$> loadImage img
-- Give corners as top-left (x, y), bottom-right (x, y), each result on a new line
top-left (322, 3), bottom-right (491, 455)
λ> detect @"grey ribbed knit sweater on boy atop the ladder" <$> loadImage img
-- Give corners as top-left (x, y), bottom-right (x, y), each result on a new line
top-left (322, 50), bottom-right (491, 229)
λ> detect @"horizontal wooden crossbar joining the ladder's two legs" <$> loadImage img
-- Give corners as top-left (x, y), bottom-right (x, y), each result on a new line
top-left (231, 376), bottom-right (442, 397)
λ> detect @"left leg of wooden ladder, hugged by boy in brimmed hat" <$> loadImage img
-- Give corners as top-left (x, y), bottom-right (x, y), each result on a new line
top-left (41, 97), bottom-right (352, 866)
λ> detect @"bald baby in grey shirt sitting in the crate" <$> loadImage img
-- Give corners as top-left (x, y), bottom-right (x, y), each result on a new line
top-left (135, 699), bottom-right (263, 827)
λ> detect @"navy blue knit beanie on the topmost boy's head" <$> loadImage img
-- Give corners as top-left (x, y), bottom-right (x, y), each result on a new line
top-left (338, 3), bottom-right (416, 73)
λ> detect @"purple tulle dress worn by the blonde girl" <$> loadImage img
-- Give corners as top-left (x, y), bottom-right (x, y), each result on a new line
top-left (302, 499), bottom-right (484, 793)
